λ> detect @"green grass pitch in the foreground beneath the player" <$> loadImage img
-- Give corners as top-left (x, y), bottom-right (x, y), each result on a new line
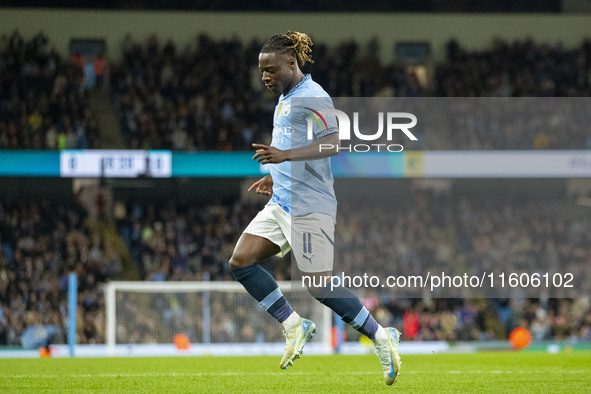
top-left (0, 351), bottom-right (591, 393)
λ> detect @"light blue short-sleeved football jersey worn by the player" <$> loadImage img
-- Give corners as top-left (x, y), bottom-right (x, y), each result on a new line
top-left (269, 74), bottom-right (338, 219)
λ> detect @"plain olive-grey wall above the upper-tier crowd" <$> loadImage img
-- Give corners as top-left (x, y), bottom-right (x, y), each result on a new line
top-left (0, 9), bottom-right (591, 61)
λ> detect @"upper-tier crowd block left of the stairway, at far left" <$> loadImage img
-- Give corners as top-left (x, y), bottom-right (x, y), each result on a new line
top-left (0, 31), bottom-right (100, 150)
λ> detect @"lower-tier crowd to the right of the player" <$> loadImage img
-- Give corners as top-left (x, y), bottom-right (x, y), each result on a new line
top-left (335, 186), bottom-right (591, 340)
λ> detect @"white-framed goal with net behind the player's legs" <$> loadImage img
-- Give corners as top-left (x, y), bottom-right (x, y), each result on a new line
top-left (104, 281), bottom-right (333, 355)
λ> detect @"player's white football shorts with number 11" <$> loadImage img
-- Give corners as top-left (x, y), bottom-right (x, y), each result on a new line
top-left (244, 204), bottom-right (334, 272)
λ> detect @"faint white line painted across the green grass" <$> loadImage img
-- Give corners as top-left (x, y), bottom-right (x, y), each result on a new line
top-left (0, 369), bottom-right (591, 379)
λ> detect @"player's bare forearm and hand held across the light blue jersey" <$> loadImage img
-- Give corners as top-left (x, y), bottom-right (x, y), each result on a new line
top-left (252, 133), bottom-right (339, 164)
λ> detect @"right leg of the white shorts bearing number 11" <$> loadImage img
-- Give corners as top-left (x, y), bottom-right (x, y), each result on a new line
top-left (291, 213), bottom-right (334, 273)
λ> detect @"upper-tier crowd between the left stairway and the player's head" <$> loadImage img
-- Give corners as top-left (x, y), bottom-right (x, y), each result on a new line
top-left (111, 35), bottom-right (273, 151)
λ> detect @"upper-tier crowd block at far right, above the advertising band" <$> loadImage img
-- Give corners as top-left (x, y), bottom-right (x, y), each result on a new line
top-left (435, 39), bottom-right (591, 149)
